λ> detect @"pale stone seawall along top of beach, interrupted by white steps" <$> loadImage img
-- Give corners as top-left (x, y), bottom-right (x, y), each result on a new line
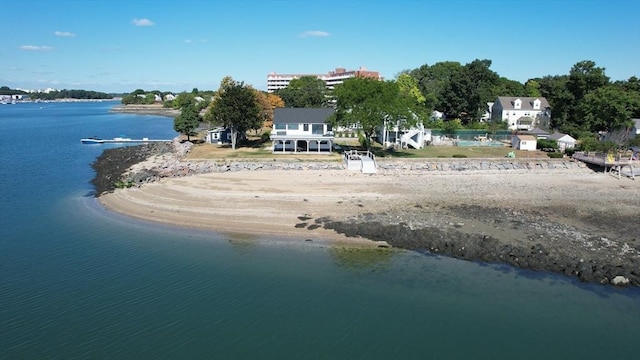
top-left (106, 140), bottom-right (586, 188)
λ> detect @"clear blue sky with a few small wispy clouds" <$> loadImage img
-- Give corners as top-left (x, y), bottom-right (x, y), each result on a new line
top-left (0, 0), bottom-right (640, 92)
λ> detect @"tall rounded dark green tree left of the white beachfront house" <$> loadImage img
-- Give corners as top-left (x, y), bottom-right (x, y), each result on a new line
top-left (209, 81), bottom-right (263, 150)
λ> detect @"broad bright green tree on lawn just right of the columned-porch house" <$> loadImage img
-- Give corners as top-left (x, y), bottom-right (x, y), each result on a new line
top-left (333, 77), bottom-right (418, 148)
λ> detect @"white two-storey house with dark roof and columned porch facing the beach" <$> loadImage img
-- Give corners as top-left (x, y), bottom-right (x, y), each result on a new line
top-left (271, 108), bottom-right (335, 154)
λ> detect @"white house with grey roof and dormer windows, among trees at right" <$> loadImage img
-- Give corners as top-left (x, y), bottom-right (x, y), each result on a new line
top-left (491, 96), bottom-right (551, 130)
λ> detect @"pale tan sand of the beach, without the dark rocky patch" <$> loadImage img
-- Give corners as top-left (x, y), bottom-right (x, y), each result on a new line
top-left (100, 168), bottom-right (640, 250)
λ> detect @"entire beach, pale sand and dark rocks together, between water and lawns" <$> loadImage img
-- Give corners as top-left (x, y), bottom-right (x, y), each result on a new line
top-left (92, 143), bottom-right (640, 286)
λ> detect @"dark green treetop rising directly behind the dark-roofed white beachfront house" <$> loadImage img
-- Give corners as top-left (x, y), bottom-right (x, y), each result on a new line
top-left (276, 76), bottom-right (327, 108)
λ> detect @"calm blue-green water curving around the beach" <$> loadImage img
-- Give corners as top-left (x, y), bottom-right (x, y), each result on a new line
top-left (0, 103), bottom-right (640, 359)
